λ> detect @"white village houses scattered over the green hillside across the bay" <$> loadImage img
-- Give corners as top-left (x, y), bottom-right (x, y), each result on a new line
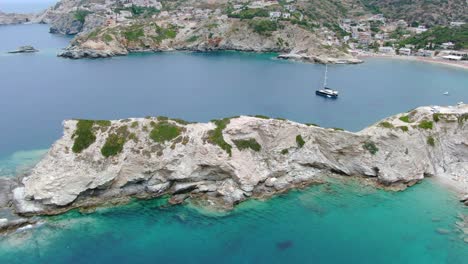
top-left (44, 0), bottom-right (468, 61)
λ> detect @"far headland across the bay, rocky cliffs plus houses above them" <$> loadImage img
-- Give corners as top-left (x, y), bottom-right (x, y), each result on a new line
top-left (0, 0), bottom-right (362, 63)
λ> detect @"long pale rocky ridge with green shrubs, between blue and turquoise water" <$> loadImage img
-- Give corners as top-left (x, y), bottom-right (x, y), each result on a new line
top-left (13, 105), bottom-right (468, 215)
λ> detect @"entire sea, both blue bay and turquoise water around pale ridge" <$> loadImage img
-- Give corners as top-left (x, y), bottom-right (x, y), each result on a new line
top-left (0, 25), bottom-right (468, 264)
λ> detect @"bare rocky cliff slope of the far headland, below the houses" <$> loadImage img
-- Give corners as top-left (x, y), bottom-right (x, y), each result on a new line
top-left (59, 17), bottom-right (362, 63)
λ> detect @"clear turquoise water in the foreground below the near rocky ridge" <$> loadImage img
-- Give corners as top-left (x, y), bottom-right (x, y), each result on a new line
top-left (0, 180), bottom-right (468, 264)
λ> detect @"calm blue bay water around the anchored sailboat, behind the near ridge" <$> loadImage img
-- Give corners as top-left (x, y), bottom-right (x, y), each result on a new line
top-left (0, 25), bottom-right (468, 157)
